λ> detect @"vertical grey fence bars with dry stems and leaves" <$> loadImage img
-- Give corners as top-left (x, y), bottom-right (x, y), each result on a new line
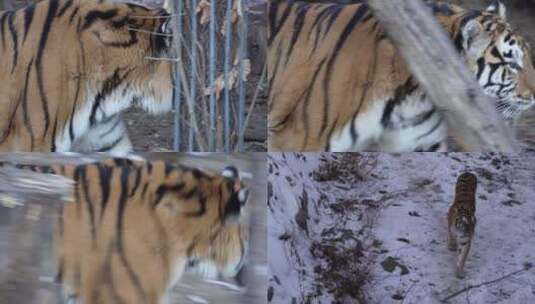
top-left (166, 0), bottom-right (265, 152)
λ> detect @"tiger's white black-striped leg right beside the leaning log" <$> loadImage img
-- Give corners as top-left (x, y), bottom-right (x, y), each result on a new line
top-left (379, 99), bottom-right (447, 152)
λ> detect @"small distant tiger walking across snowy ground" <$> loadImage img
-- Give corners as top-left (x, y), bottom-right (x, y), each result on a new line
top-left (448, 172), bottom-right (477, 278)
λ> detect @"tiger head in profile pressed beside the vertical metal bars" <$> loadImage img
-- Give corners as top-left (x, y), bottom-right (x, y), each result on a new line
top-left (77, 1), bottom-right (173, 114)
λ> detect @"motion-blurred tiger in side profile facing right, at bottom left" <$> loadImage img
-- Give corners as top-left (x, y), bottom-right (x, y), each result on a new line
top-left (3, 158), bottom-right (249, 304)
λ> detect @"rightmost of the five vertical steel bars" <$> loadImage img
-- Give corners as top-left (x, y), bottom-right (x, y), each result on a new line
top-left (238, 0), bottom-right (247, 152)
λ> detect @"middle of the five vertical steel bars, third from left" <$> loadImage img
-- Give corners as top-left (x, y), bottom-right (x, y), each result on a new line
top-left (208, 1), bottom-right (217, 152)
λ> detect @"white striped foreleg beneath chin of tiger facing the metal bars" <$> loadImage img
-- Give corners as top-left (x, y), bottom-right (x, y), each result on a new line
top-left (73, 115), bottom-right (133, 155)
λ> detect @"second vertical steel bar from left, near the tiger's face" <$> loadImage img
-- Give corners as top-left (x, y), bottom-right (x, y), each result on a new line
top-left (188, 0), bottom-right (200, 152)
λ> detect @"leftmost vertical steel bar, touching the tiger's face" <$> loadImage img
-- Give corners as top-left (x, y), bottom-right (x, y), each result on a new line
top-left (176, 0), bottom-right (184, 151)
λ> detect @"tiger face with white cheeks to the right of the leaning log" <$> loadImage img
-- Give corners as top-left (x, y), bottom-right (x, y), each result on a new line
top-left (455, 0), bottom-right (535, 121)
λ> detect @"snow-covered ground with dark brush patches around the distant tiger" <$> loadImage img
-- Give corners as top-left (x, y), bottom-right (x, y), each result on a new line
top-left (268, 153), bottom-right (535, 304)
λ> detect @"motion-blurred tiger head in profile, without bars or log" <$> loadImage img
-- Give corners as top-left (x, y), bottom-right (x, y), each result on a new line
top-left (160, 167), bottom-right (249, 278)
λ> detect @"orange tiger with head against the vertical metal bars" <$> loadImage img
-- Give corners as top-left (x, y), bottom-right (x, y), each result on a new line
top-left (0, 0), bottom-right (174, 155)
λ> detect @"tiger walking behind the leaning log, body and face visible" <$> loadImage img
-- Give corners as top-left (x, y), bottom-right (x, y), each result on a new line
top-left (267, 0), bottom-right (535, 152)
